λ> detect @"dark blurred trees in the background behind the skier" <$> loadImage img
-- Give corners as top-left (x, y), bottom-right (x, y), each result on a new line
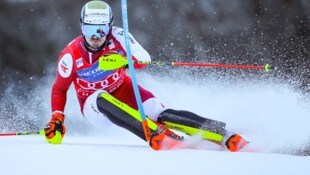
top-left (0, 0), bottom-right (310, 91)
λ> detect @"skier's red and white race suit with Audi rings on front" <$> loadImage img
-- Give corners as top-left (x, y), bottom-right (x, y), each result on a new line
top-left (51, 27), bottom-right (163, 126)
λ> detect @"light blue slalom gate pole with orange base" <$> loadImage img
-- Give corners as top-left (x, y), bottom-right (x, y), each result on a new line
top-left (122, 0), bottom-right (151, 141)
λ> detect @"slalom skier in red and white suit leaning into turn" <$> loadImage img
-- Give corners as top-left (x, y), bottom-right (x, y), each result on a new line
top-left (43, 1), bottom-right (247, 151)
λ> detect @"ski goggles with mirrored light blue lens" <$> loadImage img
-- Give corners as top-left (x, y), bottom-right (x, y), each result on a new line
top-left (82, 23), bottom-right (110, 38)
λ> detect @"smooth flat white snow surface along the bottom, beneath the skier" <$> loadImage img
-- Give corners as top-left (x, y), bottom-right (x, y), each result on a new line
top-left (0, 136), bottom-right (310, 175)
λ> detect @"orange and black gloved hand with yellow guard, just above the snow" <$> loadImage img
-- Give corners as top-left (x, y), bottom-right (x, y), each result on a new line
top-left (41, 112), bottom-right (66, 144)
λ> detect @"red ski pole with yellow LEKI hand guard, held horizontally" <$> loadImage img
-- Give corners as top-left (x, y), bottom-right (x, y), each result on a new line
top-left (99, 54), bottom-right (273, 72)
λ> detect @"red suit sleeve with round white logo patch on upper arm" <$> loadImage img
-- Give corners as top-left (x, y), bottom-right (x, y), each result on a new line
top-left (51, 52), bottom-right (75, 112)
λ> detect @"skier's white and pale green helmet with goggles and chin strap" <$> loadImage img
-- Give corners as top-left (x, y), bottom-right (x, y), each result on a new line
top-left (80, 1), bottom-right (113, 52)
